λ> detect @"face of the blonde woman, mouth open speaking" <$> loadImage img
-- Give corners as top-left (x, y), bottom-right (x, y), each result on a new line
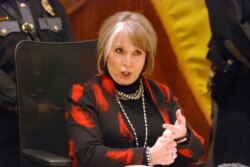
top-left (106, 35), bottom-right (146, 85)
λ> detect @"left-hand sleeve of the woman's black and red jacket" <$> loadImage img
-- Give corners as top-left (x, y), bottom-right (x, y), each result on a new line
top-left (67, 85), bottom-right (146, 167)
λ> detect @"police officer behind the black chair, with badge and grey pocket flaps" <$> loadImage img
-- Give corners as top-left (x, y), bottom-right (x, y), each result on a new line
top-left (0, 0), bottom-right (74, 167)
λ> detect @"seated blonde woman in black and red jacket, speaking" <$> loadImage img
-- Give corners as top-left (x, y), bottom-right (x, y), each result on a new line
top-left (68, 11), bottom-right (203, 167)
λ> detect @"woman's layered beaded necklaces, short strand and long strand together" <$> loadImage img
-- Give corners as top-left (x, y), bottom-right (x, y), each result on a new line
top-left (116, 80), bottom-right (148, 148)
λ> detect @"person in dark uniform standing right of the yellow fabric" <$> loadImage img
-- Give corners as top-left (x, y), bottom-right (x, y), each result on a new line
top-left (206, 0), bottom-right (250, 166)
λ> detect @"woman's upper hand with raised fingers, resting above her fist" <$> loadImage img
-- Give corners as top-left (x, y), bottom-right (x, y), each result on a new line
top-left (163, 109), bottom-right (187, 140)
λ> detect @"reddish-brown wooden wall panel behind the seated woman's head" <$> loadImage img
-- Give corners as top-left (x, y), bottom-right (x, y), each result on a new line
top-left (63, 0), bottom-right (209, 162)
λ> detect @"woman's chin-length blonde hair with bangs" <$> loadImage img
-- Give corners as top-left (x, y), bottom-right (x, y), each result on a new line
top-left (97, 11), bottom-right (157, 75)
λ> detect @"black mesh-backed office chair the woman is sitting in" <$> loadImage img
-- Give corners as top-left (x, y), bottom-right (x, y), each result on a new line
top-left (15, 40), bottom-right (97, 167)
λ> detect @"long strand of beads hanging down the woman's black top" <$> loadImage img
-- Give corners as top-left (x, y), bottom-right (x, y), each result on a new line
top-left (116, 80), bottom-right (148, 148)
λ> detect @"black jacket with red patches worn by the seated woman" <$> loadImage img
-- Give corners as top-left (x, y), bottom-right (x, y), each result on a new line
top-left (67, 75), bottom-right (204, 167)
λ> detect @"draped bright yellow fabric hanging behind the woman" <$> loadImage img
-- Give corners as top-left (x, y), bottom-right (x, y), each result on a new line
top-left (151, 0), bottom-right (211, 124)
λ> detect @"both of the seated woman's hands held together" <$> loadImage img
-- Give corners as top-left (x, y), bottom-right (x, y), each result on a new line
top-left (150, 109), bottom-right (187, 165)
